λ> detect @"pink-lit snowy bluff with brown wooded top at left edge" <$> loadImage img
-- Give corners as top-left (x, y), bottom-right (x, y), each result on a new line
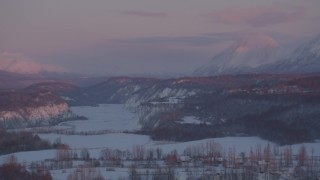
top-left (0, 92), bottom-right (74, 128)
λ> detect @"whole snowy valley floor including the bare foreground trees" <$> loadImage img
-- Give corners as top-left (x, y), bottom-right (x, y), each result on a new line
top-left (0, 104), bottom-right (320, 179)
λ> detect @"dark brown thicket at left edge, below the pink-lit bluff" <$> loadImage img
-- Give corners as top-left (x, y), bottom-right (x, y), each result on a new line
top-left (0, 129), bottom-right (54, 155)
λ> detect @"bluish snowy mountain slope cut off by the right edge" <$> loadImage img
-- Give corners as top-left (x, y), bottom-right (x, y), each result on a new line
top-left (256, 35), bottom-right (320, 73)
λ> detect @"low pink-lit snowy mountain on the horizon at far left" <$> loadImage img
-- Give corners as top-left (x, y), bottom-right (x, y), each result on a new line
top-left (0, 52), bottom-right (66, 74)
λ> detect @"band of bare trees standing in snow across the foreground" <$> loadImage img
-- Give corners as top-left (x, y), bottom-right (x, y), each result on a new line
top-left (16, 141), bottom-right (320, 180)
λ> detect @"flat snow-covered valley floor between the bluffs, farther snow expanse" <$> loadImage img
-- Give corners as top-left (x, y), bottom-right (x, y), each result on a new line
top-left (60, 104), bottom-right (141, 132)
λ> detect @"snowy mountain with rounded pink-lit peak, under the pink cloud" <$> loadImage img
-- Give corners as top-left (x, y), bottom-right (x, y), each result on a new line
top-left (195, 34), bottom-right (281, 76)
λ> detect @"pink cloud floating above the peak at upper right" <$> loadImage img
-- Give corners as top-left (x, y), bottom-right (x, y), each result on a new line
top-left (210, 4), bottom-right (305, 27)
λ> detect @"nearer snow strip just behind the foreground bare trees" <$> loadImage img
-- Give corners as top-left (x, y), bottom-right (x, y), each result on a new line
top-left (0, 133), bottom-right (320, 167)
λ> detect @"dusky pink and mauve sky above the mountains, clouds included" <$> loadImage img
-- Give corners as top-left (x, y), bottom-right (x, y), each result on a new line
top-left (0, 0), bottom-right (320, 74)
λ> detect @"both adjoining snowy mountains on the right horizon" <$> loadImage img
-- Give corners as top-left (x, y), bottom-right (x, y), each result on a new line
top-left (194, 34), bottom-right (320, 76)
